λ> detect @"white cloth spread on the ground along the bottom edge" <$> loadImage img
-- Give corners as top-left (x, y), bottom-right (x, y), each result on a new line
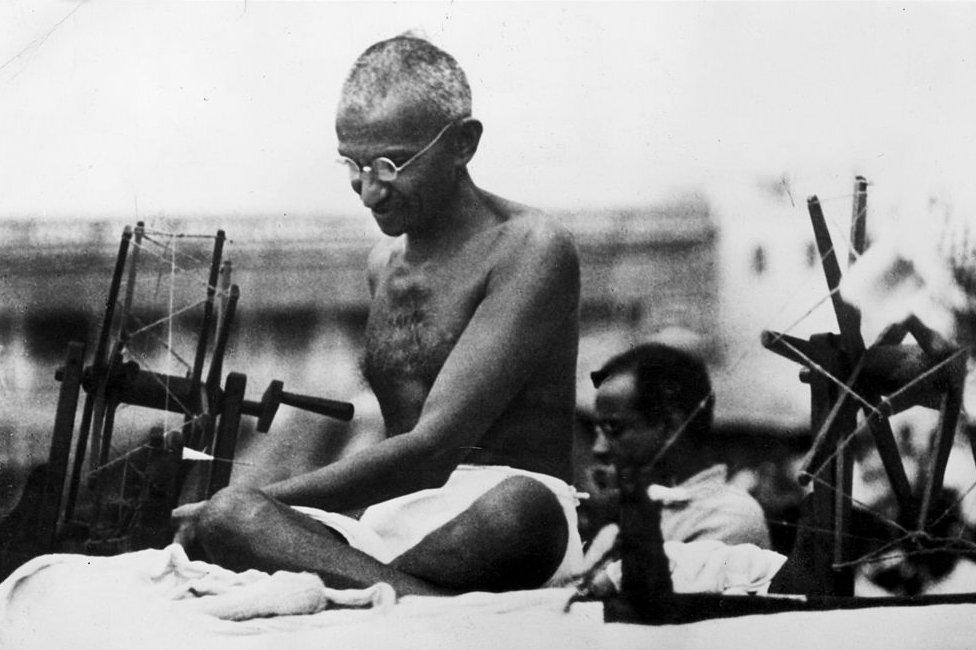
top-left (0, 547), bottom-right (976, 650)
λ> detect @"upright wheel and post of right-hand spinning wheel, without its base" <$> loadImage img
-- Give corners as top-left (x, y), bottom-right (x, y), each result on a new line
top-left (762, 177), bottom-right (976, 596)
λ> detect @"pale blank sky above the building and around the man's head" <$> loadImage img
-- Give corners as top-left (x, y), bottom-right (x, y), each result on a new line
top-left (0, 0), bottom-right (976, 219)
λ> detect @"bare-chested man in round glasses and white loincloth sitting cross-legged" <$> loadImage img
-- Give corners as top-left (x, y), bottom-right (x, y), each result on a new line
top-left (174, 36), bottom-right (582, 594)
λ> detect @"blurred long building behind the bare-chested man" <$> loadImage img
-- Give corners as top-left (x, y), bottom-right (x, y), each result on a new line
top-left (0, 193), bottom-right (822, 492)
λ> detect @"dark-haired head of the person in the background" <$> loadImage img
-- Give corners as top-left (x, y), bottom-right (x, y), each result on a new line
top-left (591, 343), bottom-right (714, 480)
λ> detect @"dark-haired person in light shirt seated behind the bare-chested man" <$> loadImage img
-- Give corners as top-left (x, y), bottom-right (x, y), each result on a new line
top-left (580, 343), bottom-right (786, 596)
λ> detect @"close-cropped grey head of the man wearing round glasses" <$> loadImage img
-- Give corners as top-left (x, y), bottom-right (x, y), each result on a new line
top-left (336, 36), bottom-right (481, 236)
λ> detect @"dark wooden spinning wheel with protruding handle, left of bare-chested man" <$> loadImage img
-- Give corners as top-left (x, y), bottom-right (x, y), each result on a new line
top-left (4, 222), bottom-right (353, 559)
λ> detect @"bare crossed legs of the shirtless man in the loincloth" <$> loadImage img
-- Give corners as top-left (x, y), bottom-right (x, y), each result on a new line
top-left (197, 476), bottom-right (568, 595)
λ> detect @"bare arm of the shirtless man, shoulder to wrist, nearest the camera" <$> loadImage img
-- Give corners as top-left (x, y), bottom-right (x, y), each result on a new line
top-left (264, 222), bottom-right (579, 511)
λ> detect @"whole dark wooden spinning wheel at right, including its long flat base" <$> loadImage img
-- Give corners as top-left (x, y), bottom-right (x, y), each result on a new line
top-left (596, 177), bottom-right (976, 624)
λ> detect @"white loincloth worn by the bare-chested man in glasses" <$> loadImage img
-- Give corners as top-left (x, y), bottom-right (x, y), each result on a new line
top-left (292, 465), bottom-right (583, 587)
